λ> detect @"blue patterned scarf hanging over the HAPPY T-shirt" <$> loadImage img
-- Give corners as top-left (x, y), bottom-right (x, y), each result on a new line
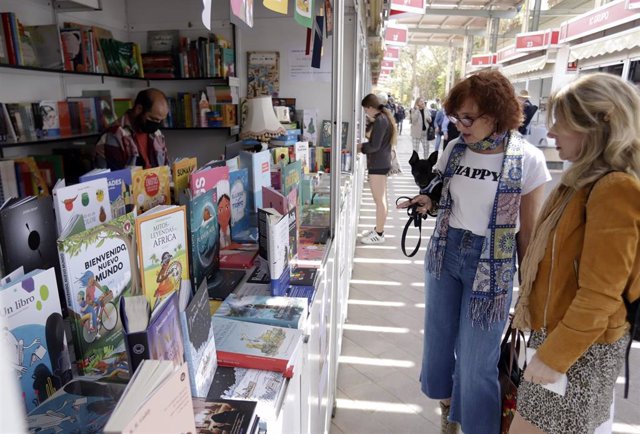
top-left (426, 134), bottom-right (524, 328)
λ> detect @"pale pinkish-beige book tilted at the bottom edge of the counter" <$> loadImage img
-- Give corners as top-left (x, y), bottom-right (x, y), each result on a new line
top-left (104, 360), bottom-right (196, 434)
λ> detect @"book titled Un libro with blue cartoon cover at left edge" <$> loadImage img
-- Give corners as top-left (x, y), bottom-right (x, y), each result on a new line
top-left (0, 268), bottom-right (71, 412)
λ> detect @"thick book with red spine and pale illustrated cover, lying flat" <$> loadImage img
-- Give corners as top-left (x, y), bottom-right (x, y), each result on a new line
top-left (213, 317), bottom-right (303, 378)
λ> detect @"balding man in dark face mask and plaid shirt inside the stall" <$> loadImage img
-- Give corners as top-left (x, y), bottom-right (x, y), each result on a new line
top-left (96, 89), bottom-right (169, 170)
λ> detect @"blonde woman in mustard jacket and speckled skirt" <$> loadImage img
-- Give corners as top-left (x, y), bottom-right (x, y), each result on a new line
top-left (510, 73), bottom-right (640, 434)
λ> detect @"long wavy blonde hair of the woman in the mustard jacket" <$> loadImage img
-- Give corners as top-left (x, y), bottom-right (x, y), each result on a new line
top-left (547, 73), bottom-right (640, 190)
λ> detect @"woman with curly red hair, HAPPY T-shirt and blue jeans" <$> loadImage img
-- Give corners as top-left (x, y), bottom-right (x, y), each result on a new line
top-left (399, 71), bottom-right (551, 434)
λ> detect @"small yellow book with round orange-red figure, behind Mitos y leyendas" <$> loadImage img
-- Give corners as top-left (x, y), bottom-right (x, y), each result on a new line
top-left (131, 166), bottom-right (171, 214)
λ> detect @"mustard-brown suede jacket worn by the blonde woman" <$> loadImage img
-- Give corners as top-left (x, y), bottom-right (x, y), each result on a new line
top-left (529, 172), bottom-right (640, 372)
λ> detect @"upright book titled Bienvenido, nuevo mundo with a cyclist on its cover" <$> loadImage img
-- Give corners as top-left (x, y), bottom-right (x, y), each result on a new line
top-left (58, 213), bottom-right (140, 377)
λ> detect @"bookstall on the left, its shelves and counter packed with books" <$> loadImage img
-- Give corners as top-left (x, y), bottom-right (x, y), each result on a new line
top-left (0, 0), bottom-right (371, 434)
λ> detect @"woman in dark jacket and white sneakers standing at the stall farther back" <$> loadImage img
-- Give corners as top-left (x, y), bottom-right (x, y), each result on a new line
top-left (359, 93), bottom-right (397, 244)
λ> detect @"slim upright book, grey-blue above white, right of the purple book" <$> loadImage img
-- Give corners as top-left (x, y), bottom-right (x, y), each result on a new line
top-left (180, 280), bottom-right (218, 397)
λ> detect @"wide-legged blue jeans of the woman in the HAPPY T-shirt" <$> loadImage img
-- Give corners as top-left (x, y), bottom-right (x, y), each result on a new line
top-left (420, 228), bottom-right (511, 434)
